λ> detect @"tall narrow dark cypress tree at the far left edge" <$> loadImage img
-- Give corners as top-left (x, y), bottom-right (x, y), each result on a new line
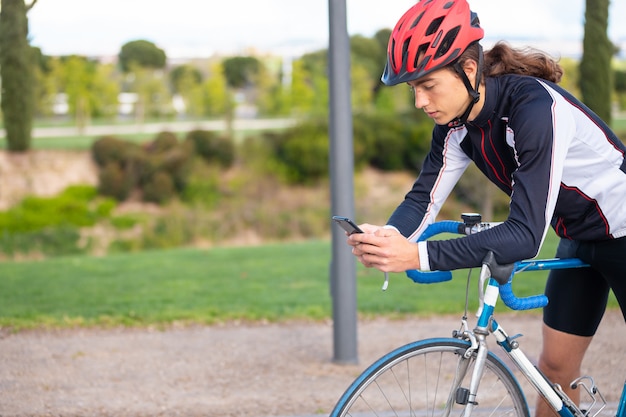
top-left (0, 0), bottom-right (37, 152)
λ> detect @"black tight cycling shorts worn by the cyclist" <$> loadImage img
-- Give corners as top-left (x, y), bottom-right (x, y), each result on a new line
top-left (543, 237), bottom-right (626, 336)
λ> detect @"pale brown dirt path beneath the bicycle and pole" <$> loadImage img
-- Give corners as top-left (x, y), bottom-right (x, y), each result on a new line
top-left (0, 311), bottom-right (626, 417)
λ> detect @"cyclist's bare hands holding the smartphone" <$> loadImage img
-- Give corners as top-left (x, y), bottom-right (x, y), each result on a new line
top-left (348, 223), bottom-right (420, 272)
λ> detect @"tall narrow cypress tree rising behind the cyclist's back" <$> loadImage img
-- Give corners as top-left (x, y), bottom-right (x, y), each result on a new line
top-left (580, 0), bottom-right (615, 123)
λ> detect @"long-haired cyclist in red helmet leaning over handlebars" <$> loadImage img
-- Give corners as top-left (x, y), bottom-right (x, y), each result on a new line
top-left (348, 0), bottom-right (626, 416)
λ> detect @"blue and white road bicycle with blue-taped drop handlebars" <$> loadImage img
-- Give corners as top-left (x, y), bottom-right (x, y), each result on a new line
top-left (330, 214), bottom-right (626, 417)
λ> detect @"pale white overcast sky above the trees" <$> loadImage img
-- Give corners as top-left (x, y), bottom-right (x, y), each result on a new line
top-left (27, 0), bottom-right (626, 59)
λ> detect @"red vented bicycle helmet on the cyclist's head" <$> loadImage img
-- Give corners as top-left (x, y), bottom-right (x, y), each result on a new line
top-left (381, 0), bottom-right (484, 85)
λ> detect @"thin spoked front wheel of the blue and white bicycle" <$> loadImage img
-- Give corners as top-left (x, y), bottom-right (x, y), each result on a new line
top-left (330, 338), bottom-right (530, 417)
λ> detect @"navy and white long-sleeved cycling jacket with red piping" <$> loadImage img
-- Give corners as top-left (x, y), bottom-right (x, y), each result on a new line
top-left (388, 75), bottom-right (626, 270)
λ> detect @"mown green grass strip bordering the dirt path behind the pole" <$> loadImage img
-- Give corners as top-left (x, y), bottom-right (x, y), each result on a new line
top-left (0, 231), bottom-right (616, 329)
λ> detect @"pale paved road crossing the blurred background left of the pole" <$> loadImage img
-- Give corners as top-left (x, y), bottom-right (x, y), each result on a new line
top-left (17, 119), bottom-right (295, 138)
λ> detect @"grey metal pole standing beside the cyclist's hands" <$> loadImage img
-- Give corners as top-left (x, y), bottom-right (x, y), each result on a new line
top-left (328, 0), bottom-right (358, 363)
